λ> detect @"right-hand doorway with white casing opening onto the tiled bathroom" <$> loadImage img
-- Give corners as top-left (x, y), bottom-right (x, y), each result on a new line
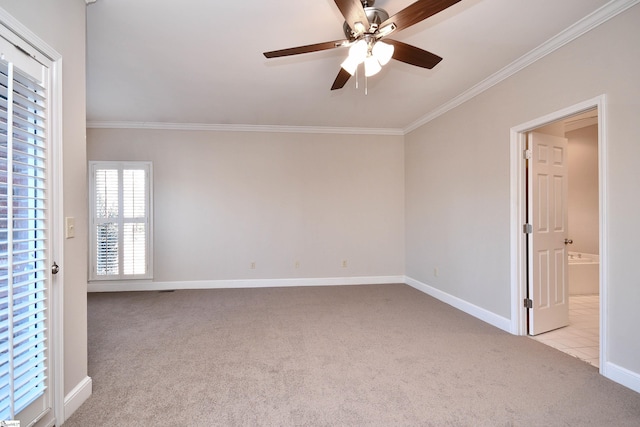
top-left (511, 96), bottom-right (607, 372)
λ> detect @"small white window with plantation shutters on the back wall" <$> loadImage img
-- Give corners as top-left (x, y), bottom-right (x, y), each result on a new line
top-left (89, 162), bottom-right (152, 280)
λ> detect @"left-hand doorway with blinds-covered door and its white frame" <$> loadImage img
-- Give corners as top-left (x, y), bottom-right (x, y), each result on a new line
top-left (0, 13), bottom-right (64, 426)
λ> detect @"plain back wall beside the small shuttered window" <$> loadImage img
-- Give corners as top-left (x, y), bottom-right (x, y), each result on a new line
top-left (88, 129), bottom-right (404, 282)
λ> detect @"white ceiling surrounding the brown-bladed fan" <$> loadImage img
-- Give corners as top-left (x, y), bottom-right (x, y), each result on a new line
top-left (87, 0), bottom-right (609, 131)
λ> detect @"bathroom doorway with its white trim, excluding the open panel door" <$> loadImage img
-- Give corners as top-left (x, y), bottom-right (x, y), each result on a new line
top-left (511, 95), bottom-right (607, 372)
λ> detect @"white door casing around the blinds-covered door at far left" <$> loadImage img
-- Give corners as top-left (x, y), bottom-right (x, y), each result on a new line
top-left (0, 7), bottom-right (65, 424)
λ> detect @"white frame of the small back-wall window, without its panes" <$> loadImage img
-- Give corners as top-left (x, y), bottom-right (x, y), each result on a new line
top-left (89, 161), bottom-right (153, 282)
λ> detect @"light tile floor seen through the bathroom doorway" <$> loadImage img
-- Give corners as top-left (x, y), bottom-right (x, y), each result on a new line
top-left (532, 295), bottom-right (600, 368)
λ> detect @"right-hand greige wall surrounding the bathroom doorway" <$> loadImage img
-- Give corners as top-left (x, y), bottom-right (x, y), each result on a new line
top-left (405, 5), bottom-right (640, 374)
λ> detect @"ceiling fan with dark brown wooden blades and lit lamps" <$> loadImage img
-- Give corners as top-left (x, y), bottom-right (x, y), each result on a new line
top-left (264, 0), bottom-right (460, 90)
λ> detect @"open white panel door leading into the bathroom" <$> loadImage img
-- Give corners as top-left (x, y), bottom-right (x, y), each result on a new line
top-left (528, 132), bottom-right (569, 335)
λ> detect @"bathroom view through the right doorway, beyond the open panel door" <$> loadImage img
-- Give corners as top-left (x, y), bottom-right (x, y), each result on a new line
top-left (527, 108), bottom-right (600, 367)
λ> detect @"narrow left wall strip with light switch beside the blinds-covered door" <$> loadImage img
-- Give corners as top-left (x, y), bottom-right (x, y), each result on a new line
top-left (0, 0), bottom-right (87, 404)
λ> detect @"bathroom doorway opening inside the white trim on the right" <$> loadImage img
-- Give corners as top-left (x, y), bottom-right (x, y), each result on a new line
top-left (527, 108), bottom-right (600, 367)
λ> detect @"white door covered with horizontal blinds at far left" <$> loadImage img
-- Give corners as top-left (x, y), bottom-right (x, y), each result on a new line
top-left (0, 31), bottom-right (55, 426)
